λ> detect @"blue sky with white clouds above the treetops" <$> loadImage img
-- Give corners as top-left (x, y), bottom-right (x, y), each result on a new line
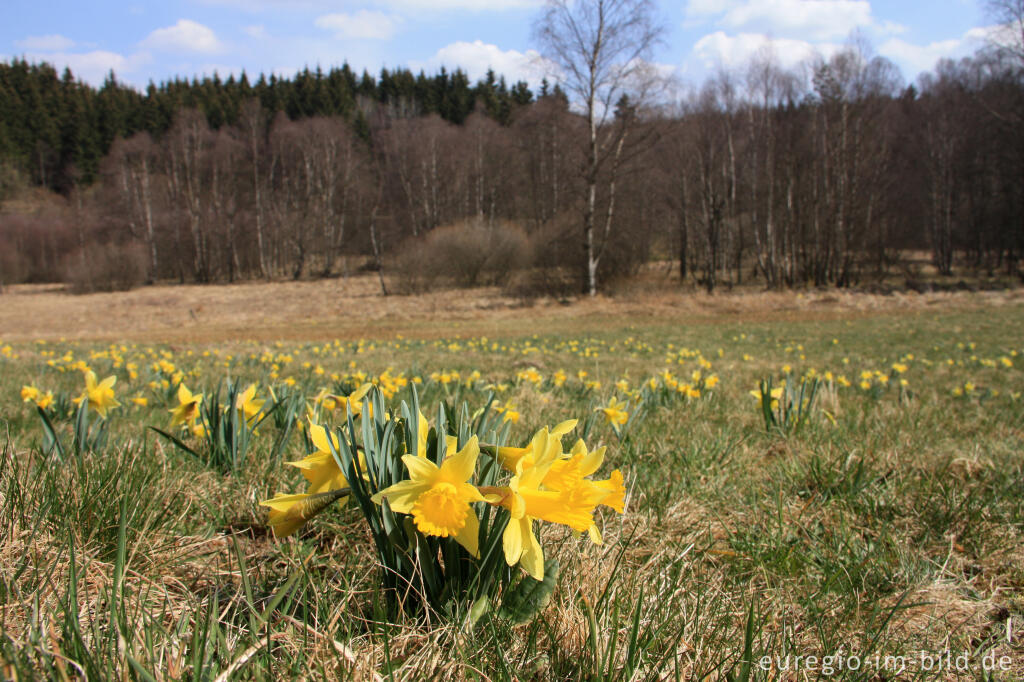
top-left (0, 0), bottom-right (985, 88)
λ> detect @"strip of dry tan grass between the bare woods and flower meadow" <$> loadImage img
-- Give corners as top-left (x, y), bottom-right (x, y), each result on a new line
top-left (0, 275), bottom-right (1024, 343)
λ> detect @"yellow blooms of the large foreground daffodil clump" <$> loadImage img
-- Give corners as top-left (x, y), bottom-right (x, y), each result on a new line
top-left (260, 396), bottom-right (626, 580)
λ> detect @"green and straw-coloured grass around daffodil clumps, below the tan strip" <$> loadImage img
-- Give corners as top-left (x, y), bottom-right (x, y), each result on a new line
top-left (0, 294), bottom-right (1024, 680)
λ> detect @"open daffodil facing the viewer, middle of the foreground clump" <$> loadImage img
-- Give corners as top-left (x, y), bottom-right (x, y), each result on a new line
top-left (373, 436), bottom-right (484, 556)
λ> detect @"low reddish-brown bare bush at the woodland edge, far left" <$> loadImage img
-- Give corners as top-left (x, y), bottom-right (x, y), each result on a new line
top-left (61, 244), bottom-right (146, 294)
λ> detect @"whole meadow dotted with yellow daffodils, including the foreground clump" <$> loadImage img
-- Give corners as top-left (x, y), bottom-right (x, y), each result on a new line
top-left (0, 294), bottom-right (1024, 680)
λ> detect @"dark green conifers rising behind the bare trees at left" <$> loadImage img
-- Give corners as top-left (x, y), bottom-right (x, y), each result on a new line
top-left (0, 58), bottom-right (547, 194)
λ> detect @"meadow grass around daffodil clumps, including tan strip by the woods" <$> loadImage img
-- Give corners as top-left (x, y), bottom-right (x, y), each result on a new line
top-left (0, 276), bottom-right (1024, 682)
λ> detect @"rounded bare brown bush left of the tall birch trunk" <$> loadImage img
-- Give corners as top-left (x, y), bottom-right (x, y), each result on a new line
top-left (385, 220), bottom-right (529, 294)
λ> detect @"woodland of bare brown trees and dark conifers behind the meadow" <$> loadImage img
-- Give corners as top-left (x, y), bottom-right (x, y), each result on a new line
top-left (0, 32), bottom-right (1024, 295)
